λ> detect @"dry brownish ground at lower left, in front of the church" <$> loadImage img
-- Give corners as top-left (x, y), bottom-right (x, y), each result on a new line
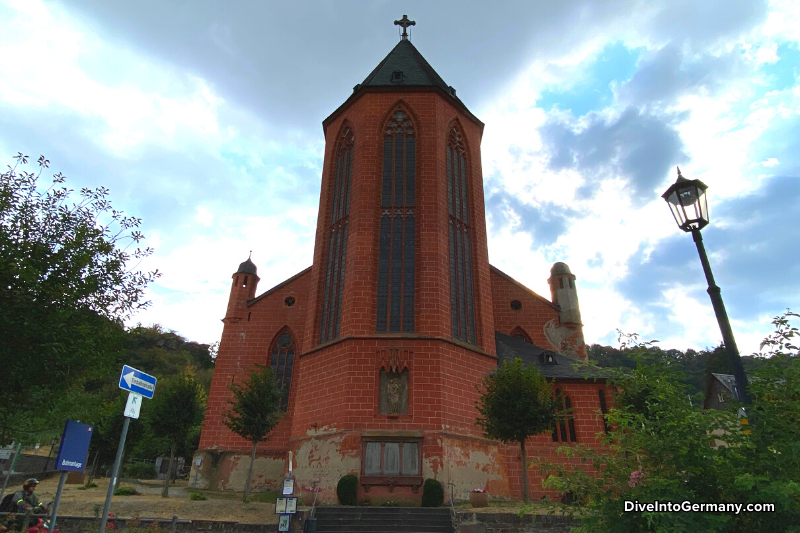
top-left (28, 477), bottom-right (278, 524)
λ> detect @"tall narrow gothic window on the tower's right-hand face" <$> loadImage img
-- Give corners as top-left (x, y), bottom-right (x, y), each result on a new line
top-left (446, 126), bottom-right (475, 344)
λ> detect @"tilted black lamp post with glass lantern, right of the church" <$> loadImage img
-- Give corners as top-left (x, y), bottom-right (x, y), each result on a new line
top-left (661, 168), bottom-right (750, 404)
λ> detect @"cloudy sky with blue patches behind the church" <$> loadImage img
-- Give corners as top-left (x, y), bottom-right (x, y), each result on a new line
top-left (0, 0), bottom-right (800, 354)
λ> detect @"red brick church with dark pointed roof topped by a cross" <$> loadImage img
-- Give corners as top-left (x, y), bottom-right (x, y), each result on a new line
top-left (190, 16), bottom-right (606, 502)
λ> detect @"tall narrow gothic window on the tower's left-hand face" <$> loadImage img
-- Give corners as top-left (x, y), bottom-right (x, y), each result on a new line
top-left (319, 126), bottom-right (354, 342)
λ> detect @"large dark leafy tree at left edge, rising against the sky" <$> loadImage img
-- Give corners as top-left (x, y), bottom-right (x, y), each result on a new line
top-left (0, 153), bottom-right (158, 444)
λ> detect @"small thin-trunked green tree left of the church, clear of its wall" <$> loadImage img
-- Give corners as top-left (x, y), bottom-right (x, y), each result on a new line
top-left (143, 374), bottom-right (206, 498)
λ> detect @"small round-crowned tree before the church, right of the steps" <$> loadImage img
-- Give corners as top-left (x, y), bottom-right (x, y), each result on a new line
top-left (476, 359), bottom-right (555, 503)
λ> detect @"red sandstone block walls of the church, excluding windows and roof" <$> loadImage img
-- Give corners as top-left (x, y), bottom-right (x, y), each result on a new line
top-left (200, 82), bottom-right (611, 497)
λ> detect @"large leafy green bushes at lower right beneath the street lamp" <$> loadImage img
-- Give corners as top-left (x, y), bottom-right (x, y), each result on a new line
top-left (537, 313), bottom-right (800, 533)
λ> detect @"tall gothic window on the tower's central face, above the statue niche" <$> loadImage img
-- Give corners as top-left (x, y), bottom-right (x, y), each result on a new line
top-left (375, 108), bottom-right (417, 333)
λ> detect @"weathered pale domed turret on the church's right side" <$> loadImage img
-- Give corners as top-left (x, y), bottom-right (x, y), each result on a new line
top-left (545, 263), bottom-right (586, 360)
